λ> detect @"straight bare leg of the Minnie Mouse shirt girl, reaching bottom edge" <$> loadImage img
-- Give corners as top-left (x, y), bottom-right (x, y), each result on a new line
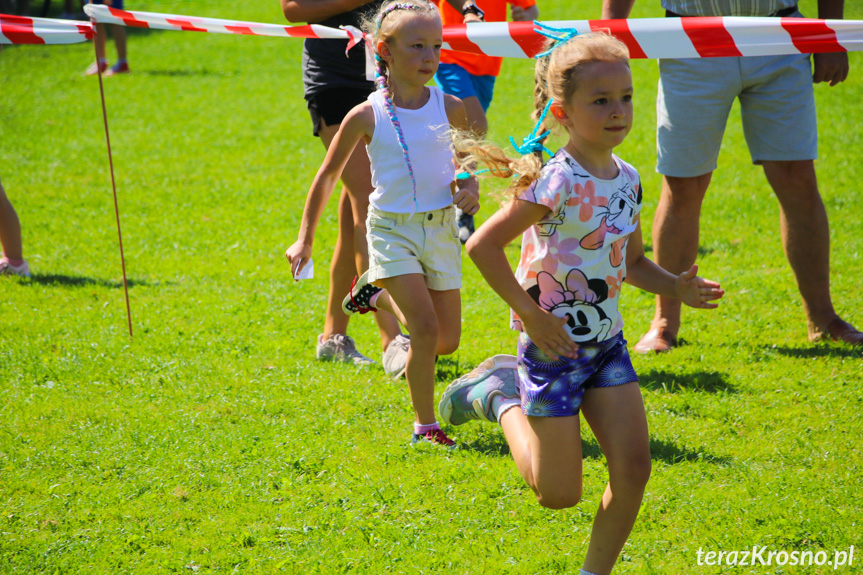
top-left (580, 383), bottom-right (650, 575)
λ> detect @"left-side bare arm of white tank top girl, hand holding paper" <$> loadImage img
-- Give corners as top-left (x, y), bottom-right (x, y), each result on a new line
top-left (285, 106), bottom-right (375, 277)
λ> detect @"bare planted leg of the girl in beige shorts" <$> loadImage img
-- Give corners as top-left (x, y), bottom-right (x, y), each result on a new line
top-left (375, 274), bottom-right (438, 425)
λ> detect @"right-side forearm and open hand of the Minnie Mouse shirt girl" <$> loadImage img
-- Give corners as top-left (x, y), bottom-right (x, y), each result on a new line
top-left (626, 218), bottom-right (725, 309)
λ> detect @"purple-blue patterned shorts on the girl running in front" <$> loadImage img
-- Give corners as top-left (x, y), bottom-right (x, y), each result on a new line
top-left (518, 332), bottom-right (638, 417)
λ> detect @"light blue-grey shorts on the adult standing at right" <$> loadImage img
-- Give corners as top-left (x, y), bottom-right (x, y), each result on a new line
top-left (656, 54), bottom-right (818, 178)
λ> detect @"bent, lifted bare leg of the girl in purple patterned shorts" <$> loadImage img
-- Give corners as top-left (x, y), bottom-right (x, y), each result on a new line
top-left (500, 407), bottom-right (582, 509)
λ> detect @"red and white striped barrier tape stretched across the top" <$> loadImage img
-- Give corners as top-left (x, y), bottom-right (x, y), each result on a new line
top-left (10, 4), bottom-right (863, 58)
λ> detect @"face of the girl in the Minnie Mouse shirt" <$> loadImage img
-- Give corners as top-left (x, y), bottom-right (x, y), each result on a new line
top-left (551, 61), bottom-right (632, 159)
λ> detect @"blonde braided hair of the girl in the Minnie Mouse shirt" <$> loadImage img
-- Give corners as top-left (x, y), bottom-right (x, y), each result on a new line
top-left (453, 32), bottom-right (629, 197)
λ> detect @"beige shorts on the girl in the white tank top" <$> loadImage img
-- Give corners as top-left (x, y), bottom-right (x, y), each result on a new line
top-left (366, 206), bottom-right (461, 291)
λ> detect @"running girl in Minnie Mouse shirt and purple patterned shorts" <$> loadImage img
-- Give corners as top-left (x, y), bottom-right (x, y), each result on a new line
top-left (440, 33), bottom-right (723, 575)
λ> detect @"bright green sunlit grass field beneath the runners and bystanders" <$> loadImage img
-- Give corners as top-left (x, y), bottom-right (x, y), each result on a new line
top-left (0, 0), bottom-right (863, 574)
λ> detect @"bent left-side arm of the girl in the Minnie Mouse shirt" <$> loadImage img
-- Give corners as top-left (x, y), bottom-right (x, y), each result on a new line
top-left (466, 200), bottom-right (578, 359)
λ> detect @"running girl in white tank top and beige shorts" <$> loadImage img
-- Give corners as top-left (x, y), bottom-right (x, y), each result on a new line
top-left (285, 0), bottom-right (479, 446)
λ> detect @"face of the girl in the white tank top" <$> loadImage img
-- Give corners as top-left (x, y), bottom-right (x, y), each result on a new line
top-left (378, 10), bottom-right (443, 86)
